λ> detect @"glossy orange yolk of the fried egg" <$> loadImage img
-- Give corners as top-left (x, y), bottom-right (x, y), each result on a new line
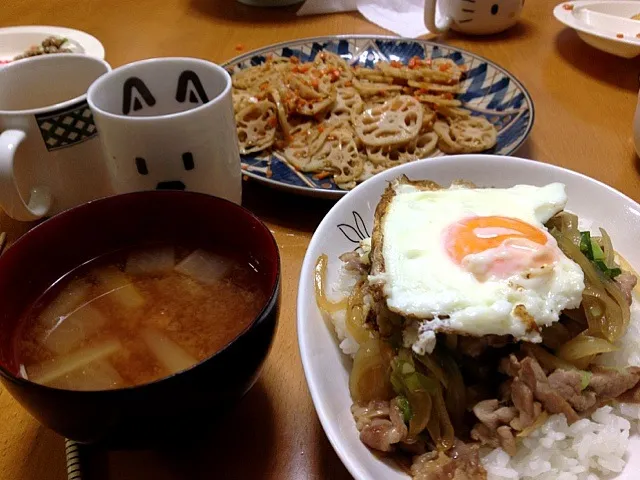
top-left (444, 216), bottom-right (547, 264)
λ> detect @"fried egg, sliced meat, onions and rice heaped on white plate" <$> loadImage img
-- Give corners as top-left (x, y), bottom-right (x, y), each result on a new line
top-left (315, 177), bottom-right (640, 480)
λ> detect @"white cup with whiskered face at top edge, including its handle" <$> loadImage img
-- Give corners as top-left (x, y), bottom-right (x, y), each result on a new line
top-left (424, 0), bottom-right (524, 35)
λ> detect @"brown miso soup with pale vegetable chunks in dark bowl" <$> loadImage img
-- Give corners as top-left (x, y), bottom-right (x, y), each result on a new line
top-left (14, 245), bottom-right (267, 390)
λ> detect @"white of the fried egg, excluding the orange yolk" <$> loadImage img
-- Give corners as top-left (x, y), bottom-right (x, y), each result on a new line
top-left (369, 183), bottom-right (584, 353)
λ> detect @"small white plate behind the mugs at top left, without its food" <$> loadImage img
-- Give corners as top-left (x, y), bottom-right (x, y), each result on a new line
top-left (0, 25), bottom-right (104, 62)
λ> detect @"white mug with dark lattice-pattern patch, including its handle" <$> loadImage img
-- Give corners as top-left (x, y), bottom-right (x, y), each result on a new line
top-left (0, 53), bottom-right (111, 221)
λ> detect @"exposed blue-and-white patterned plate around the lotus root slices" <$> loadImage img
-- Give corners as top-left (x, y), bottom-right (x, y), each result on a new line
top-left (223, 35), bottom-right (534, 198)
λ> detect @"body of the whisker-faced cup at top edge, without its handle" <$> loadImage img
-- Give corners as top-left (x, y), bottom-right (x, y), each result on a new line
top-left (449, 0), bottom-right (524, 33)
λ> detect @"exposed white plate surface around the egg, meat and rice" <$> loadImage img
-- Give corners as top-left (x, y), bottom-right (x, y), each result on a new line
top-left (297, 155), bottom-right (640, 480)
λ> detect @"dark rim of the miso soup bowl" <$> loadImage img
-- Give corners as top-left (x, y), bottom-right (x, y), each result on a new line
top-left (0, 190), bottom-right (282, 396)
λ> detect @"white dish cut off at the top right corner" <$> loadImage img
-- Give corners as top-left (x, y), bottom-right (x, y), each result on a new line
top-left (553, 0), bottom-right (640, 58)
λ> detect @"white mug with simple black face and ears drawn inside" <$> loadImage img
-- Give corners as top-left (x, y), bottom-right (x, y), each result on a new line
top-left (88, 58), bottom-right (242, 203)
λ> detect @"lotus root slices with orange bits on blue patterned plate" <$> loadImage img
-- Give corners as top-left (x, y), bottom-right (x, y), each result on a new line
top-left (232, 52), bottom-right (497, 190)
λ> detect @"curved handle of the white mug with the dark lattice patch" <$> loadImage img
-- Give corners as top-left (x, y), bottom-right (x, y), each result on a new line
top-left (0, 130), bottom-right (52, 221)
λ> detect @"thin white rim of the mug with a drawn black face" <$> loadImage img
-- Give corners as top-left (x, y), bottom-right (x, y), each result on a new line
top-left (87, 57), bottom-right (232, 122)
